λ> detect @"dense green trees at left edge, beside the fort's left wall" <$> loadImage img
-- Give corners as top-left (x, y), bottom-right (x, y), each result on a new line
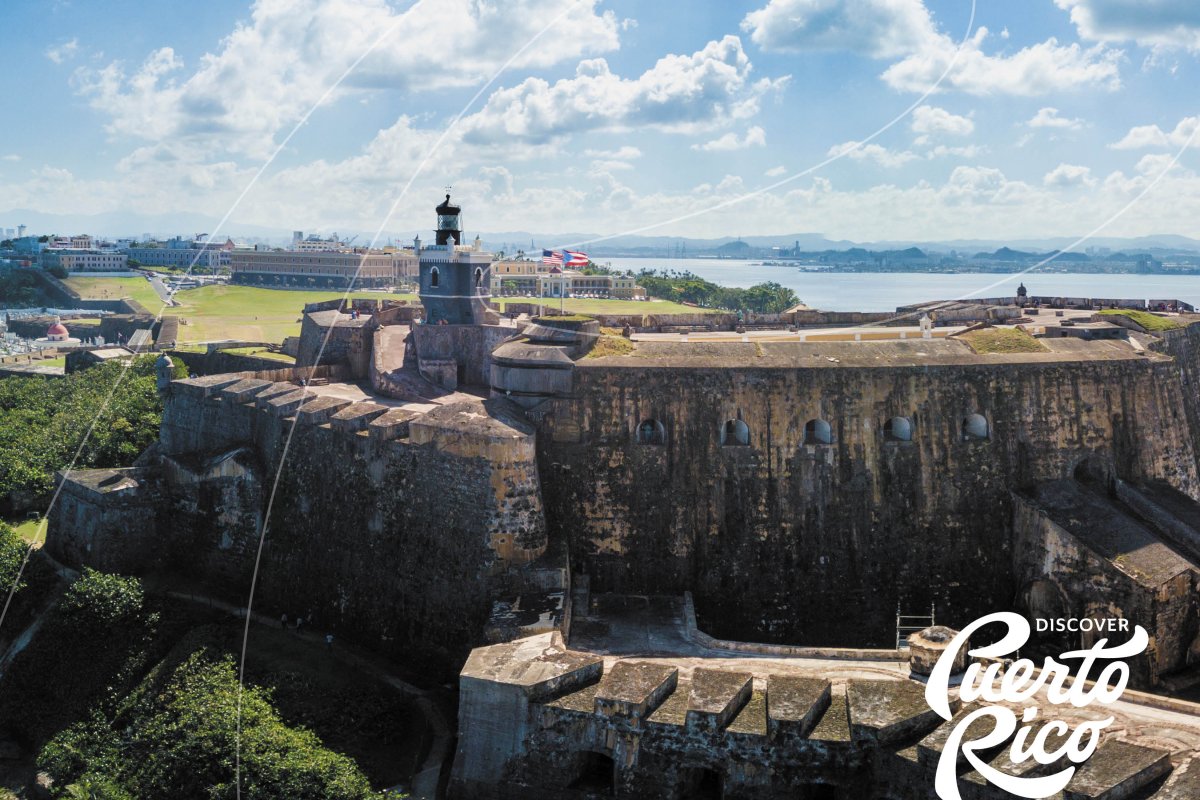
top-left (0, 355), bottom-right (186, 511)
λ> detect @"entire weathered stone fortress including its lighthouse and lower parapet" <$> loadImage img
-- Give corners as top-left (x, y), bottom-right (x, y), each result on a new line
top-left (46, 196), bottom-right (1200, 800)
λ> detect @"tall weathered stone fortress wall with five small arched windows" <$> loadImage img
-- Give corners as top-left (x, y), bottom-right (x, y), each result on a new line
top-left (539, 343), bottom-right (1200, 662)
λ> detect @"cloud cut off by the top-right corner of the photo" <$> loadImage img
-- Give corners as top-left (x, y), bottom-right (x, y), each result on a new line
top-left (1055, 0), bottom-right (1200, 50)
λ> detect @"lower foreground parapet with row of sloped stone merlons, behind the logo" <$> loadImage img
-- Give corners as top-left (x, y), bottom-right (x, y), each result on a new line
top-left (450, 633), bottom-right (1200, 800)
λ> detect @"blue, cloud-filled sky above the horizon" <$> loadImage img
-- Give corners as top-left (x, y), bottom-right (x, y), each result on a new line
top-left (0, 0), bottom-right (1200, 245)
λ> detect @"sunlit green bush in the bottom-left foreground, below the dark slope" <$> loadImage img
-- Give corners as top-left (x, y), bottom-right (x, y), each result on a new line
top-left (38, 650), bottom-right (380, 800)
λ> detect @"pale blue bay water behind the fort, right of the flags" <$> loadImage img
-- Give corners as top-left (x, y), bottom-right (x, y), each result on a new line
top-left (596, 257), bottom-right (1200, 311)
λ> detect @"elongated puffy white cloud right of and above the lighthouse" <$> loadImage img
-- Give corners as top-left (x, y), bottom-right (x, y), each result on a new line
top-left (462, 36), bottom-right (787, 145)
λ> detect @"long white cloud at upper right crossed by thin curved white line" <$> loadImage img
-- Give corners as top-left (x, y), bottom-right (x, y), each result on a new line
top-left (742, 0), bottom-right (1122, 96)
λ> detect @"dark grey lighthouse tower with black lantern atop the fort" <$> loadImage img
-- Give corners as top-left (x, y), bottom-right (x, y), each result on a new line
top-left (414, 194), bottom-right (492, 325)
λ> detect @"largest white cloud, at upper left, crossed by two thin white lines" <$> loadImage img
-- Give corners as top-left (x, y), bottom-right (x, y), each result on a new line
top-left (74, 0), bottom-right (619, 157)
